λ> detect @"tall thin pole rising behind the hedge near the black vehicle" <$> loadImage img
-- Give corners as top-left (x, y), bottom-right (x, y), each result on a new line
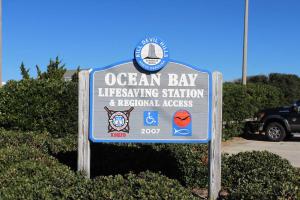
top-left (242, 0), bottom-right (249, 85)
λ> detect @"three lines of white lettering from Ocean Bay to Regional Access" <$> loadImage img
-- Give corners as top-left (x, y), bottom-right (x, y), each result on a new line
top-left (97, 72), bottom-right (207, 107)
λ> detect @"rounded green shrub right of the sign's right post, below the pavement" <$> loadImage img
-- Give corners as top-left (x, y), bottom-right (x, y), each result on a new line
top-left (222, 151), bottom-right (299, 200)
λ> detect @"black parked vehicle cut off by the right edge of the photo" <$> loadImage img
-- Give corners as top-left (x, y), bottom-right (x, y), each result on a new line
top-left (245, 100), bottom-right (300, 141)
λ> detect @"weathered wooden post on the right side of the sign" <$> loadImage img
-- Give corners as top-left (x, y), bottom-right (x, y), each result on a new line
top-left (208, 72), bottom-right (223, 200)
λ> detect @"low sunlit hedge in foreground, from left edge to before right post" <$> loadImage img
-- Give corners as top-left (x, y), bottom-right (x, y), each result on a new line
top-left (0, 144), bottom-right (197, 199)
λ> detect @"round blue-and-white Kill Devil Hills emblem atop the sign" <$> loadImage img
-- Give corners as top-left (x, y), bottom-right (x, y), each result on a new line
top-left (134, 37), bottom-right (169, 72)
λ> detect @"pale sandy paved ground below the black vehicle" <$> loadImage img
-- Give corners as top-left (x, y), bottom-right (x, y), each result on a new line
top-left (222, 135), bottom-right (300, 168)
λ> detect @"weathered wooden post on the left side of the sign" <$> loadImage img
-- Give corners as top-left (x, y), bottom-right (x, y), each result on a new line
top-left (77, 70), bottom-right (91, 178)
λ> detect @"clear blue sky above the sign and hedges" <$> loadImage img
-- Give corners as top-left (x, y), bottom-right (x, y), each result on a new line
top-left (3, 0), bottom-right (300, 81)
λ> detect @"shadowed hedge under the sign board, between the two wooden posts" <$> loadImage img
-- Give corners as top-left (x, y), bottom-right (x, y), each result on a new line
top-left (87, 144), bottom-right (208, 188)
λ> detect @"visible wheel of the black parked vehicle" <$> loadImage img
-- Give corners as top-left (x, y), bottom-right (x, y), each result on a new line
top-left (266, 122), bottom-right (286, 142)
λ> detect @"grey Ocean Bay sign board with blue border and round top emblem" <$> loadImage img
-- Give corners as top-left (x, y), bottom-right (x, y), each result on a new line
top-left (89, 37), bottom-right (212, 143)
